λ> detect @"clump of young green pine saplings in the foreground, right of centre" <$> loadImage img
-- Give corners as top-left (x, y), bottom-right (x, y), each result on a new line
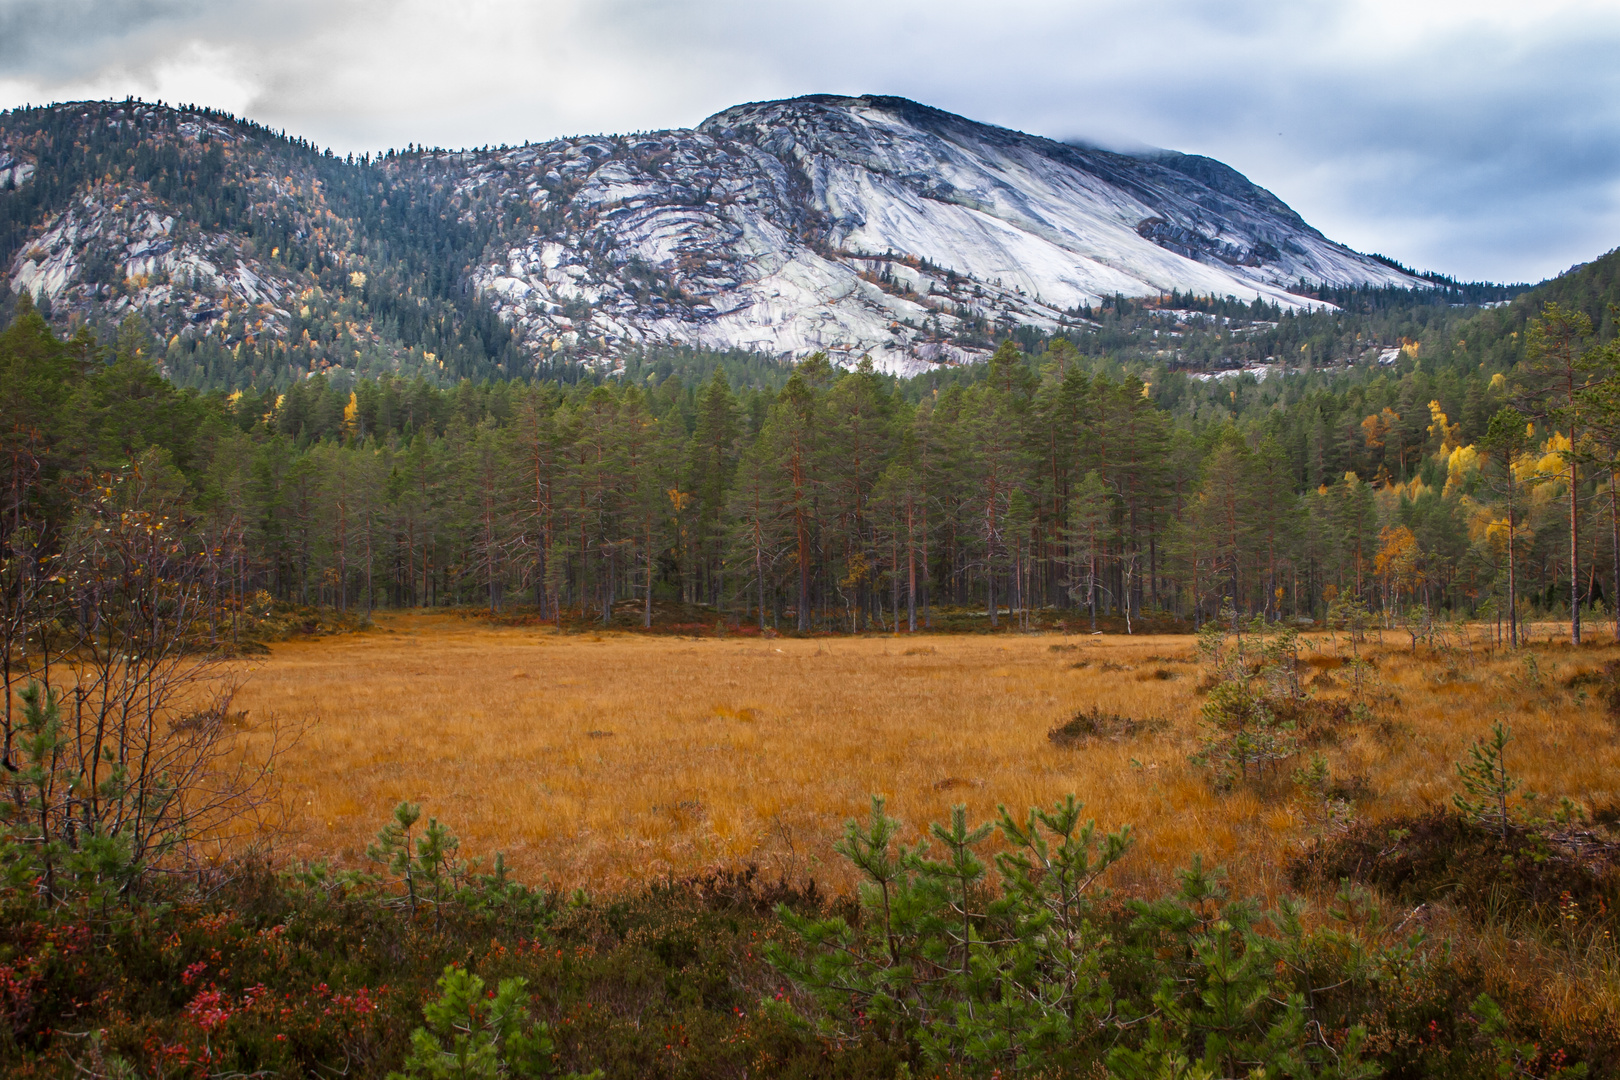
top-left (770, 798), bottom-right (1131, 1075)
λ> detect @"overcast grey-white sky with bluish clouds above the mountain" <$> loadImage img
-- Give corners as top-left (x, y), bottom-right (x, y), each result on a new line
top-left (0, 0), bottom-right (1620, 280)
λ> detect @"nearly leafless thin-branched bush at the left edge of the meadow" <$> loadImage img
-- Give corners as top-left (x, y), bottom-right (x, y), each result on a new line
top-left (5, 457), bottom-right (296, 891)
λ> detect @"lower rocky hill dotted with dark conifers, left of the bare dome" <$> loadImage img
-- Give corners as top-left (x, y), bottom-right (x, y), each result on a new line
top-left (0, 102), bottom-right (528, 385)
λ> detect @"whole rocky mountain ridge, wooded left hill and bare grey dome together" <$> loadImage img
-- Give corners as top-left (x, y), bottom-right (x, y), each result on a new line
top-left (0, 96), bottom-right (1426, 385)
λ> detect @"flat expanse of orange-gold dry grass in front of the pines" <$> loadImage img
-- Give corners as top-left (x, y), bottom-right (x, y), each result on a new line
top-left (238, 614), bottom-right (1620, 894)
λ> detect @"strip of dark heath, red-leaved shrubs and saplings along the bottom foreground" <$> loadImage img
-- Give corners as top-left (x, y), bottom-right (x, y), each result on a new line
top-left (0, 800), bottom-right (1620, 1080)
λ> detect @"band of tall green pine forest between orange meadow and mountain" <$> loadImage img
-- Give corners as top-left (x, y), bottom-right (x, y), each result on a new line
top-left (9, 298), bottom-right (1620, 654)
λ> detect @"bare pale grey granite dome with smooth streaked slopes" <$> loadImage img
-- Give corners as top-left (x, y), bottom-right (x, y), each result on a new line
top-left (465, 97), bottom-right (1421, 371)
